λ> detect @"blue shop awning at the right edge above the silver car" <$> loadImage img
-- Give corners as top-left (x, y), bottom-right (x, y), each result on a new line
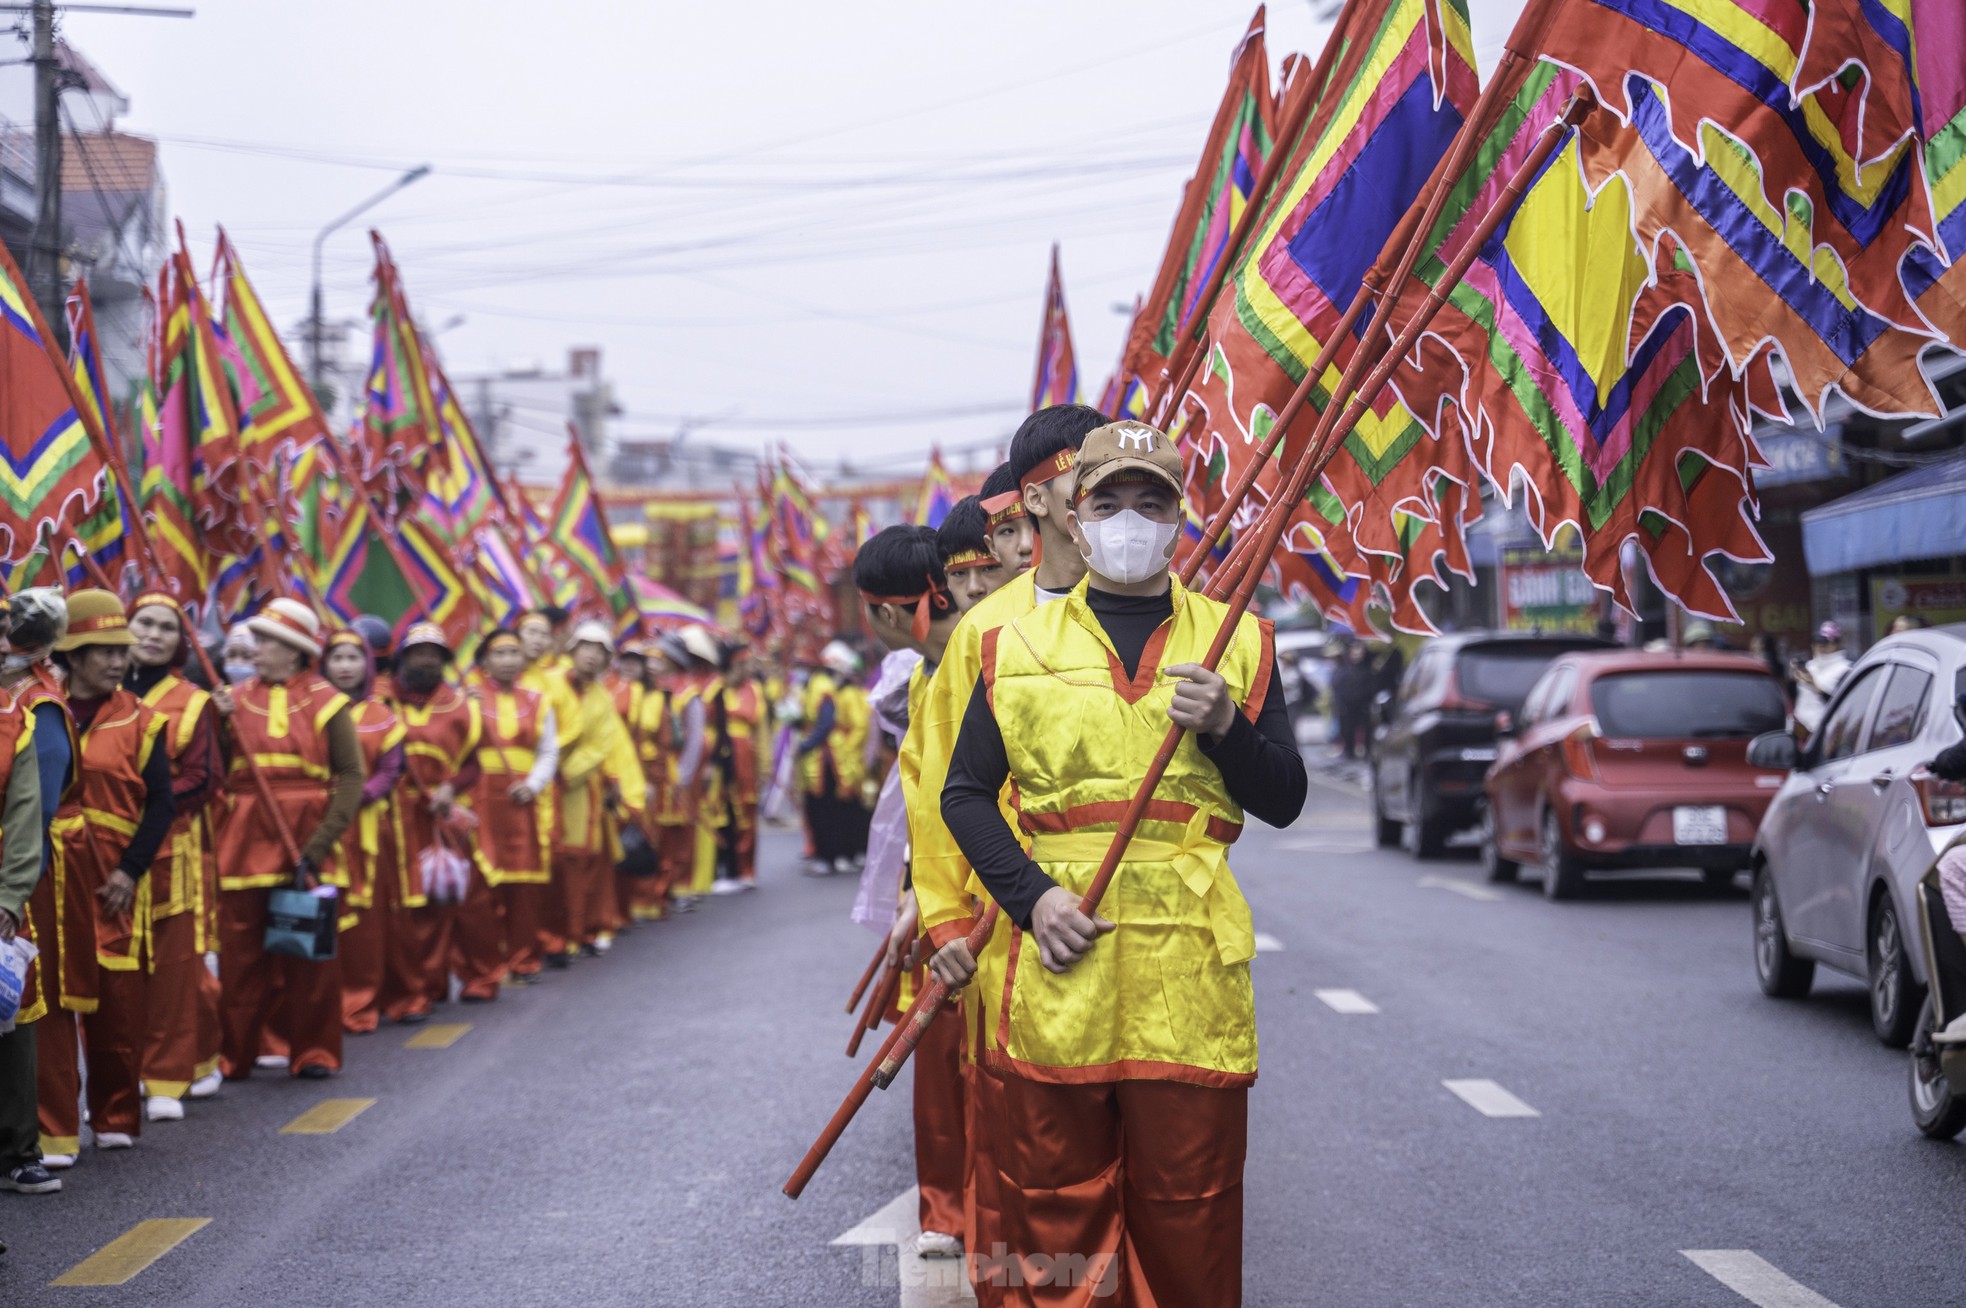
top-left (1803, 456), bottom-right (1966, 576)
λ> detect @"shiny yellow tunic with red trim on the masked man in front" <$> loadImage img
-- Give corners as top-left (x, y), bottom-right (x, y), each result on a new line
top-left (981, 582), bottom-right (1274, 1086)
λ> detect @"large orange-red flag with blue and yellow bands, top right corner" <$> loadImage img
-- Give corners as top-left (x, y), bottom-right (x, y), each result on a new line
top-left (1522, 0), bottom-right (1958, 415)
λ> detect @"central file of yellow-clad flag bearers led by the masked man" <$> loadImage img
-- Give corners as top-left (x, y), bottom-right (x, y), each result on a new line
top-left (853, 405), bottom-right (1307, 1304)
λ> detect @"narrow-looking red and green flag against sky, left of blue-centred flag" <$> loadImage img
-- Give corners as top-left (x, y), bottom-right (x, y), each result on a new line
top-left (1107, 6), bottom-right (1276, 415)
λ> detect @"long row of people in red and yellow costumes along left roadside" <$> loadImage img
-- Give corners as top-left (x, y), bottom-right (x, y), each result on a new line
top-left (0, 590), bottom-right (773, 1194)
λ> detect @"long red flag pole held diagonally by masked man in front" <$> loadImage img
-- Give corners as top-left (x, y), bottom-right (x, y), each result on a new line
top-left (784, 81), bottom-right (1594, 1198)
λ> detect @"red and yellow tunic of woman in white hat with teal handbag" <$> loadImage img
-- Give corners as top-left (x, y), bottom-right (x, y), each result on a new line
top-left (212, 673), bottom-right (348, 891)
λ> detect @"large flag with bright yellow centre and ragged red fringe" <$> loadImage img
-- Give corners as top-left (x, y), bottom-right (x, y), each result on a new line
top-left (1388, 52), bottom-right (1767, 618)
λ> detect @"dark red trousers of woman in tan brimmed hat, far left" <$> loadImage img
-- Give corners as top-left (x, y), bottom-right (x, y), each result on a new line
top-left (33, 968), bottom-right (149, 1153)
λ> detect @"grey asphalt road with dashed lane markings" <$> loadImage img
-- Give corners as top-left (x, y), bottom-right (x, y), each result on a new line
top-left (0, 751), bottom-right (1966, 1308)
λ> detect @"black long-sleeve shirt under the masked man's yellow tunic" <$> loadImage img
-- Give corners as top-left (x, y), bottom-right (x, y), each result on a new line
top-left (942, 588), bottom-right (1309, 930)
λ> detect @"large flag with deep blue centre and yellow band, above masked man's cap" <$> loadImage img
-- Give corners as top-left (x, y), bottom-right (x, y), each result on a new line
top-left (1178, 0), bottom-right (1478, 617)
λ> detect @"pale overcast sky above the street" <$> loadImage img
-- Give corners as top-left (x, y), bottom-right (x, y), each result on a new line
top-left (42, 0), bottom-right (1520, 474)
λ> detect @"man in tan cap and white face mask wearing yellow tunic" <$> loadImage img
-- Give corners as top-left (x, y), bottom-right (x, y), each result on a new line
top-left (942, 421), bottom-right (1307, 1306)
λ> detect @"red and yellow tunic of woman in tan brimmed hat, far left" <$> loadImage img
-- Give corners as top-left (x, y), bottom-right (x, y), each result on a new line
top-left (51, 688), bottom-right (169, 972)
